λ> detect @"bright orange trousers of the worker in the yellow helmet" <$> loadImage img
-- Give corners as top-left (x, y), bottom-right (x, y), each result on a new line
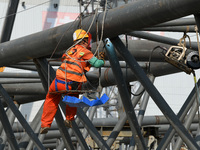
top-left (41, 79), bottom-right (79, 128)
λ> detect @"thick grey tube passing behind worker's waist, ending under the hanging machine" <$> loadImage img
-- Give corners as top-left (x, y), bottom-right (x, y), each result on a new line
top-left (0, 63), bottom-right (181, 96)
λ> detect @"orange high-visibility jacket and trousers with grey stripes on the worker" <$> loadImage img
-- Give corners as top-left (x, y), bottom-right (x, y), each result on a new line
top-left (41, 45), bottom-right (94, 128)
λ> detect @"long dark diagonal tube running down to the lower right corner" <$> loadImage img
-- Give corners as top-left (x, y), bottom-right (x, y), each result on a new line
top-left (111, 37), bottom-right (199, 150)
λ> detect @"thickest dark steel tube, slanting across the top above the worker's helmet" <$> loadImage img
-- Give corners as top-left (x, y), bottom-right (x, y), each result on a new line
top-left (0, 0), bottom-right (200, 66)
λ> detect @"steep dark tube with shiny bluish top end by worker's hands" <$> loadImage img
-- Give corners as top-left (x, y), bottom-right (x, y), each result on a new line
top-left (105, 39), bottom-right (146, 150)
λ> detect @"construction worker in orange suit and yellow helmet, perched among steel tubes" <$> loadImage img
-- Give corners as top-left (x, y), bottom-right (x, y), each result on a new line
top-left (40, 29), bottom-right (104, 134)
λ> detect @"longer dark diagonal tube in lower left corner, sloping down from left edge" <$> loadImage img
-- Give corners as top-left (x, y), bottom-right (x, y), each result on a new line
top-left (0, 84), bottom-right (45, 150)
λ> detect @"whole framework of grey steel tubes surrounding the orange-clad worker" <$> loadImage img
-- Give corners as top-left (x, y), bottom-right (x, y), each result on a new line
top-left (0, 0), bottom-right (200, 150)
